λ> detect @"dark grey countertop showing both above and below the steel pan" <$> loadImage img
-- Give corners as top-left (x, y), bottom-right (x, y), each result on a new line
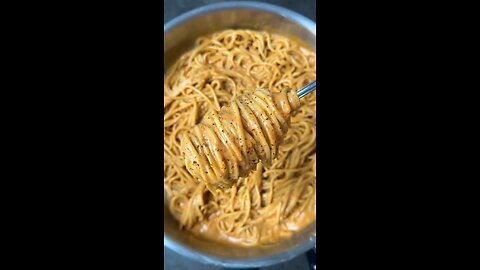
top-left (163, 0), bottom-right (317, 270)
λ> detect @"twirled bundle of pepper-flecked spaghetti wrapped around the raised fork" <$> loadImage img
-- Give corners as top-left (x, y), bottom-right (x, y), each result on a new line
top-left (182, 89), bottom-right (300, 190)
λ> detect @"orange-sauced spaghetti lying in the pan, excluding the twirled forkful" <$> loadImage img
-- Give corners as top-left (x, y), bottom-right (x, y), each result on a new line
top-left (164, 30), bottom-right (316, 245)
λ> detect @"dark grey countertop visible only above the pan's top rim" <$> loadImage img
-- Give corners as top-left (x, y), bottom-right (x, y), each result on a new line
top-left (163, 0), bottom-right (317, 23)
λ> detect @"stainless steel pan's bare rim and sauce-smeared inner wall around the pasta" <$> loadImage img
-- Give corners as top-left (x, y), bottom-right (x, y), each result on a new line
top-left (163, 2), bottom-right (316, 267)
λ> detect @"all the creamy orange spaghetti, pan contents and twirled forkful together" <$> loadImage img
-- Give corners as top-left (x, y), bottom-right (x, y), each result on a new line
top-left (164, 30), bottom-right (316, 247)
